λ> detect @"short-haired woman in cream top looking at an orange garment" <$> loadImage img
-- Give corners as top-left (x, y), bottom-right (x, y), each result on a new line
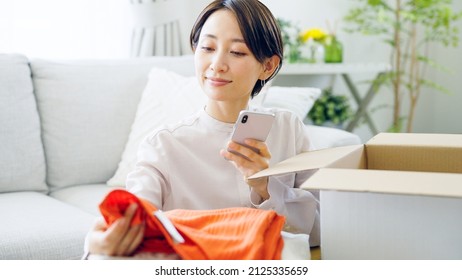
top-left (87, 0), bottom-right (318, 256)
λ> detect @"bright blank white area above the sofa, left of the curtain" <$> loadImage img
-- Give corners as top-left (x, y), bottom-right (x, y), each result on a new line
top-left (0, 0), bottom-right (131, 59)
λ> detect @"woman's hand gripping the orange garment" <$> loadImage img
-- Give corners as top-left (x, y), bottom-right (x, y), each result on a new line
top-left (87, 204), bottom-right (144, 256)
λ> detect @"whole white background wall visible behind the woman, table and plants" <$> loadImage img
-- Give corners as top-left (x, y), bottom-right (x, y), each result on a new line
top-left (0, 0), bottom-right (462, 141)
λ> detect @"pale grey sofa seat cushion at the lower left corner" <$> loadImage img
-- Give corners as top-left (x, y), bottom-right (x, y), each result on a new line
top-left (0, 192), bottom-right (95, 260)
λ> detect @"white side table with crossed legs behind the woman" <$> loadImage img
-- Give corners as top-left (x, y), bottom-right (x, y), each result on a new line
top-left (278, 63), bottom-right (391, 135)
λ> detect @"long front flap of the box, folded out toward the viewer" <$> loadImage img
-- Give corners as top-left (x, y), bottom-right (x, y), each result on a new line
top-left (301, 168), bottom-right (462, 197)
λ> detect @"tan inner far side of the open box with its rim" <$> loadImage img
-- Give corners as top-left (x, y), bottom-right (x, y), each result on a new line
top-left (366, 133), bottom-right (462, 173)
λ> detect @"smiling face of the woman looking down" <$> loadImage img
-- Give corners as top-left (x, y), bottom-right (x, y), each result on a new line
top-left (194, 10), bottom-right (266, 104)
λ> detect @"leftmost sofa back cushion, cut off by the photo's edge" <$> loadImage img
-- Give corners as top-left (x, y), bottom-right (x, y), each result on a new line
top-left (0, 55), bottom-right (47, 192)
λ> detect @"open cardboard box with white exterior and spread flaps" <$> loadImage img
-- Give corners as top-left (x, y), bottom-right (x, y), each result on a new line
top-left (254, 133), bottom-right (462, 259)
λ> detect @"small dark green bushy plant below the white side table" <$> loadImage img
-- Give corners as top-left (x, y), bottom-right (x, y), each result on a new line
top-left (308, 88), bottom-right (352, 128)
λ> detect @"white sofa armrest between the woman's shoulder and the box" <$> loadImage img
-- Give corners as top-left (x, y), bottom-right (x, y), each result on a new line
top-left (305, 125), bottom-right (362, 150)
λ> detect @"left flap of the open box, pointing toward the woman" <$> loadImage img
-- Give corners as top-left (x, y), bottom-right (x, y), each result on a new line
top-left (249, 145), bottom-right (364, 179)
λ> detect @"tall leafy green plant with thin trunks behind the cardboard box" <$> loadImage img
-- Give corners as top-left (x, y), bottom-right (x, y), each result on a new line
top-left (345, 0), bottom-right (462, 132)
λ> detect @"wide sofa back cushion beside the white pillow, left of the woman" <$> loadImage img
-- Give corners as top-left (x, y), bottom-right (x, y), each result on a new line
top-left (31, 56), bottom-right (194, 189)
